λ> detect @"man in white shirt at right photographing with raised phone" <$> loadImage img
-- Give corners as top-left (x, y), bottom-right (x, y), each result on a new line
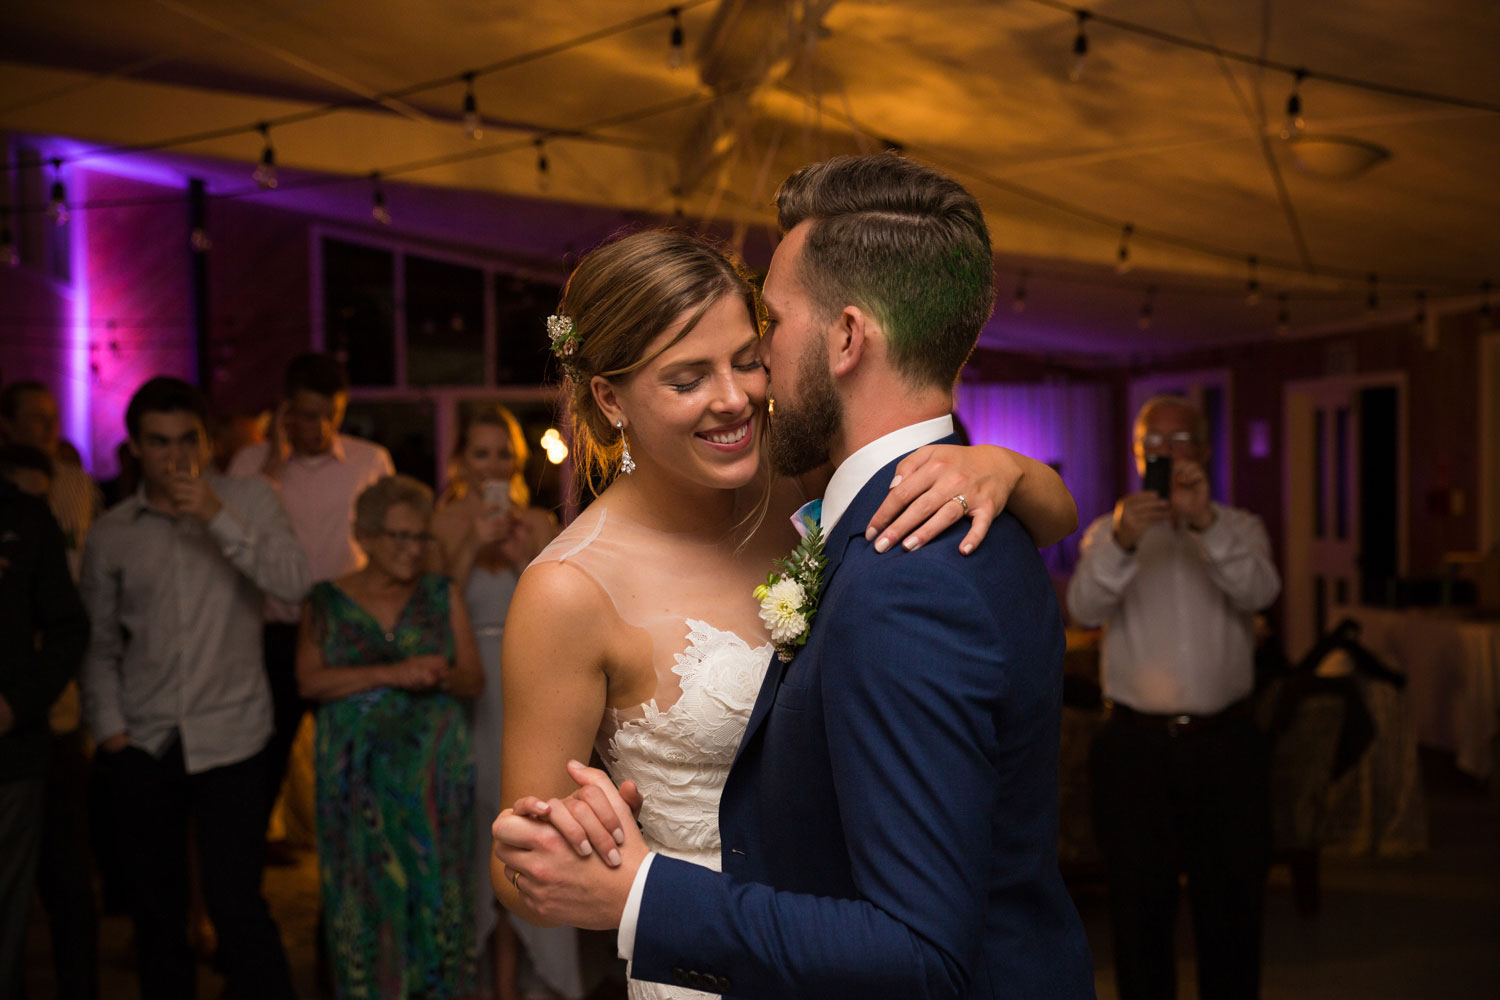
top-left (1068, 396), bottom-right (1281, 1000)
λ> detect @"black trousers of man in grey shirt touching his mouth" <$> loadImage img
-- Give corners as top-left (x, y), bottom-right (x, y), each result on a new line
top-left (107, 741), bottom-right (296, 1000)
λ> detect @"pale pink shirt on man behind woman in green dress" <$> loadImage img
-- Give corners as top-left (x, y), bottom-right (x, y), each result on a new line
top-left (230, 435), bottom-right (396, 624)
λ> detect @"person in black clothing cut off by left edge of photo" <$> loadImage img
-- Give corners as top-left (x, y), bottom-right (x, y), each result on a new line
top-left (0, 476), bottom-right (89, 997)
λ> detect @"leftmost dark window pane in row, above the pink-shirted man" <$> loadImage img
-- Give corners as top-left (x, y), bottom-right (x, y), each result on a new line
top-left (323, 240), bottom-right (396, 385)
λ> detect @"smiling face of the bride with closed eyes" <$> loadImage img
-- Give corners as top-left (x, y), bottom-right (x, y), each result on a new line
top-left (606, 295), bottom-right (767, 489)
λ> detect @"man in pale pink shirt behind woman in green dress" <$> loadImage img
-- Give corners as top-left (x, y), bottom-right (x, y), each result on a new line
top-left (230, 354), bottom-right (396, 808)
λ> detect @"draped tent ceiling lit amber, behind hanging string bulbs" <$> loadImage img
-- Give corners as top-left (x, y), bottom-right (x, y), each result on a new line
top-left (0, 0), bottom-right (1500, 355)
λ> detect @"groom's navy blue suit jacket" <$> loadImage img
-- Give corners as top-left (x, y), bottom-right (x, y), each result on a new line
top-left (632, 446), bottom-right (1094, 1000)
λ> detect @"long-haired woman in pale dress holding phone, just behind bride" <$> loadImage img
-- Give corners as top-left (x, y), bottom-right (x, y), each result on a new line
top-left (432, 406), bottom-right (584, 1000)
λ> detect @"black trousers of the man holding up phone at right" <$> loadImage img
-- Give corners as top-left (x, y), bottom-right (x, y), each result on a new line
top-left (1089, 715), bottom-right (1271, 1000)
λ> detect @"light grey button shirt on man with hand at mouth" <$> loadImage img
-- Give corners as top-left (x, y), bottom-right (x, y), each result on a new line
top-left (80, 474), bottom-right (308, 774)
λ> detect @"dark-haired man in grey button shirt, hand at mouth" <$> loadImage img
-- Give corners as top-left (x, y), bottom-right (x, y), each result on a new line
top-left (81, 378), bottom-right (308, 1000)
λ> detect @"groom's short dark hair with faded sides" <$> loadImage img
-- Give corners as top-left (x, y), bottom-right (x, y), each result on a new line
top-left (776, 153), bottom-right (995, 387)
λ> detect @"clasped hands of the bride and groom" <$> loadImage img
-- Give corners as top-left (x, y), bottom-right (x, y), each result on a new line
top-left (491, 760), bottom-right (647, 930)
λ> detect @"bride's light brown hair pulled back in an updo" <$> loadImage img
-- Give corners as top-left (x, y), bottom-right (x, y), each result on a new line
top-left (558, 229), bottom-right (759, 495)
